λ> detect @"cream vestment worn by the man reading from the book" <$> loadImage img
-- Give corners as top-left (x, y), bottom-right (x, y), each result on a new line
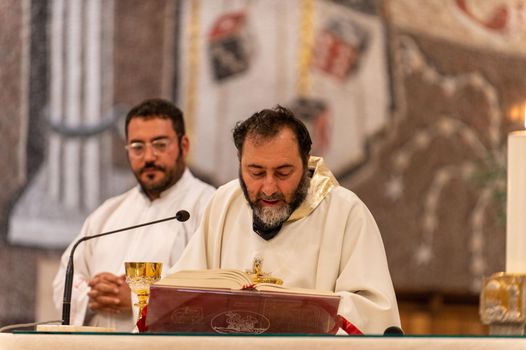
top-left (172, 157), bottom-right (400, 334)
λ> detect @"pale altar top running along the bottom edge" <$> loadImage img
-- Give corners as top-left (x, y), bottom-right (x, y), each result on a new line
top-left (0, 332), bottom-right (526, 350)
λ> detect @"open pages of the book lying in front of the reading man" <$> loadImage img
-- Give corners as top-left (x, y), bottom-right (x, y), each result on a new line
top-left (156, 269), bottom-right (335, 295)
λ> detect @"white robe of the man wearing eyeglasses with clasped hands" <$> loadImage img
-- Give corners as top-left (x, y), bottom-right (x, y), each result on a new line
top-left (53, 169), bottom-right (214, 332)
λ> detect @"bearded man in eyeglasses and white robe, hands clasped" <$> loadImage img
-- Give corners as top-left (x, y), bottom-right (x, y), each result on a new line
top-left (53, 99), bottom-right (214, 331)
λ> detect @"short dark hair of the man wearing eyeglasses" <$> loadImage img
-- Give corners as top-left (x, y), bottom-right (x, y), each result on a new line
top-left (125, 98), bottom-right (185, 139)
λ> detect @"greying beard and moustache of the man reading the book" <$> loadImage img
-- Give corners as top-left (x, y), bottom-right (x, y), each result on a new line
top-left (239, 169), bottom-right (310, 231)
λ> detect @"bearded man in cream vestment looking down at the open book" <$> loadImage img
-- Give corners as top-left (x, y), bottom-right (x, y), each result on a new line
top-left (172, 106), bottom-right (400, 334)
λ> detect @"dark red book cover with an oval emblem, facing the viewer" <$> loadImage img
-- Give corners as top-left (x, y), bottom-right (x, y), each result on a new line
top-left (146, 284), bottom-right (340, 334)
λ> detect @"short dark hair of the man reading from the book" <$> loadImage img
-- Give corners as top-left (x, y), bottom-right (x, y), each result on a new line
top-left (232, 105), bottom-right (312, 166)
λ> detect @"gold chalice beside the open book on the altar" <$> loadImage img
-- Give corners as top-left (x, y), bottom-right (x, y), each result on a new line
top-left (124, 262), bottom-right (163, 320)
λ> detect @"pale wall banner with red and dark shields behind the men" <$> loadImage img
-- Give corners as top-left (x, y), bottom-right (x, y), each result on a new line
top-left (177, 0), bottom-right (389, 184)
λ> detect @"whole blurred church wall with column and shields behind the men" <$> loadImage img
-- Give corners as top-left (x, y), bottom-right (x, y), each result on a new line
top-left (0, 0), bottom-right (526, 334)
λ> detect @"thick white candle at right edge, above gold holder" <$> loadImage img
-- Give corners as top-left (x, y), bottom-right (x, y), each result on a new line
top-left (506, 118), bottom-right (526, 273)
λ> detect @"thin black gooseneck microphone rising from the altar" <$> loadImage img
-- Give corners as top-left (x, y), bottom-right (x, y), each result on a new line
top-left (62, 210), bottom-right (190, 325)
